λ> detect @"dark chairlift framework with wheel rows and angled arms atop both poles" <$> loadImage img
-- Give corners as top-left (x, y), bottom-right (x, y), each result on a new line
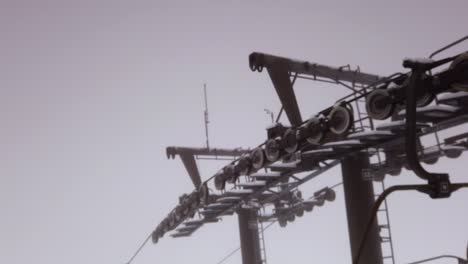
top-left (146, 38), bottom-right (468, 263)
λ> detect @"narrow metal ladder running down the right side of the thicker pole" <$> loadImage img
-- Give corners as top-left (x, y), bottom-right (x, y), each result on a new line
top-left (374, 180), bottom-right (395, 264)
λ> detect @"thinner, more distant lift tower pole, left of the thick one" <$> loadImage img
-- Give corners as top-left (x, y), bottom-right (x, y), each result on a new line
top-left (237, 208), bottom-right (262, 264)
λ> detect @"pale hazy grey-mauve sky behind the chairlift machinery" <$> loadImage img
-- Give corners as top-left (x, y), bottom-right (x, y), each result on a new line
top-left (0, 0), bottom-right (468, 264)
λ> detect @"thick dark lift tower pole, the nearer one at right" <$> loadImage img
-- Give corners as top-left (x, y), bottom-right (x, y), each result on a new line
top-left (341, 153), bottom-right (383, 264)
